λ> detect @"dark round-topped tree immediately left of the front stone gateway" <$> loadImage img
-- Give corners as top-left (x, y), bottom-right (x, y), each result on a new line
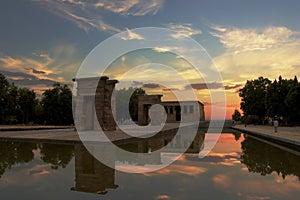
top-left (41, 83), bottom-right (73, 125)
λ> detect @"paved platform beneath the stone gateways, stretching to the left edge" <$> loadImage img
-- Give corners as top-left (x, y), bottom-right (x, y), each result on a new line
top-left (0, 123), bottom-right (191, 143)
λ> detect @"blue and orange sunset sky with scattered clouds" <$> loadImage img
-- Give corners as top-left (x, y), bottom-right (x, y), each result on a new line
top-left (0, 0), bottom-right (300, 118)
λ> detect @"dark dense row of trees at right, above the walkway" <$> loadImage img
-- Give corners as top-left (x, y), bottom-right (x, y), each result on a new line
top-left (232, 76), bottom-right (300, 124)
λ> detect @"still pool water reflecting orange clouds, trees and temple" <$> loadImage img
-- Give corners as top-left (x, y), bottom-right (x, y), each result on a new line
top-left (0, 134), bottom-right (300, 200)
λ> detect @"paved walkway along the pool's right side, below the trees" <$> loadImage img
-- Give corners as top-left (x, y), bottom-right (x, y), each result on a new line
top-left (233, 125), bottom-right (300, 148)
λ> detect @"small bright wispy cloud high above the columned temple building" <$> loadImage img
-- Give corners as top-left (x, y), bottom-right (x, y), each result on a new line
top-left (167, 23), bottom-right (202, 39)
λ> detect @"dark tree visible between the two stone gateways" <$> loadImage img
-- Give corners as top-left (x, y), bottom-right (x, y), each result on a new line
top-left (116, 87), bottom-right (145, 121)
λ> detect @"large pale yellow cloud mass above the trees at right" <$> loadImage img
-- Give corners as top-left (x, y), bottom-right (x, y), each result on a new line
top-left (211, 25), bottom-right (300, 81)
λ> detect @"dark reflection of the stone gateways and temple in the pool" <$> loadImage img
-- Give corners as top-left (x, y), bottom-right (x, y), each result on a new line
top-left (71, 134), bottom-right (205, 194)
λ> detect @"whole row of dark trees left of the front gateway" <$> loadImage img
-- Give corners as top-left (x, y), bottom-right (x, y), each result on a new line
top-left (0, 74), bottom-right (73, 125)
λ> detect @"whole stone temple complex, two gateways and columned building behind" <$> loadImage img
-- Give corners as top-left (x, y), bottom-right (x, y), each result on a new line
top-left (73, 76), bottom-right (205, 131)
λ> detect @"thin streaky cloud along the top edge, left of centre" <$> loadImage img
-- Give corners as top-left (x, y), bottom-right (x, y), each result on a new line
top-left (33, 0), bottom-right (164, 33)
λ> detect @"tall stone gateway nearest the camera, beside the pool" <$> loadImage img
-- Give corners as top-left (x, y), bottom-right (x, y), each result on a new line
top-left (74, 76), bottom-right (118, 131)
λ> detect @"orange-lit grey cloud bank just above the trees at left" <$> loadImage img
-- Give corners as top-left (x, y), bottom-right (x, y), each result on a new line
top-left (0, 45), bottom-right (80, 87)
